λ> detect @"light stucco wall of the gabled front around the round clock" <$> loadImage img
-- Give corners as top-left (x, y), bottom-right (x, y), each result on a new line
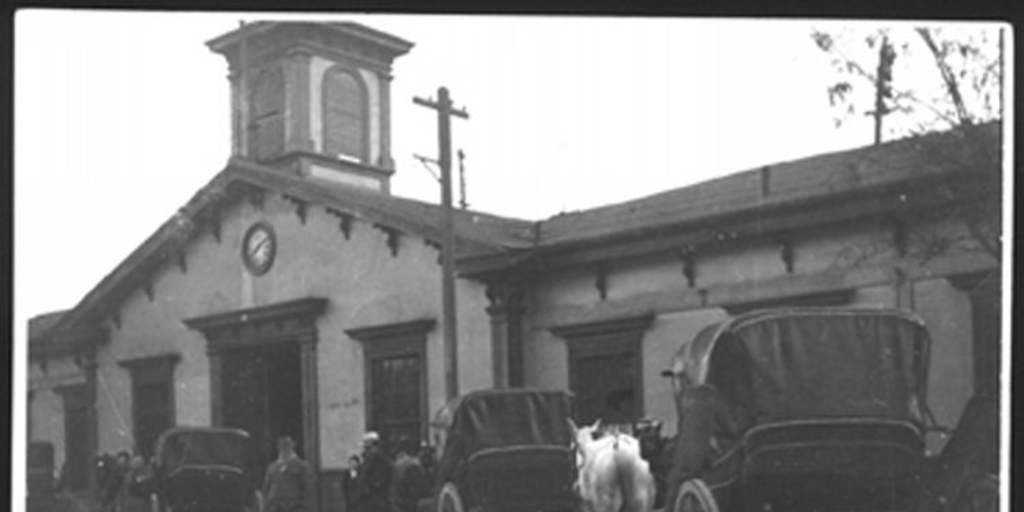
top-left (79, 189), bottom-right (492, 469)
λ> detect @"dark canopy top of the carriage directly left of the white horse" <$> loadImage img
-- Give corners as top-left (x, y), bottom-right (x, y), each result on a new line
top-left (431, 389), bottom-right (571, 455)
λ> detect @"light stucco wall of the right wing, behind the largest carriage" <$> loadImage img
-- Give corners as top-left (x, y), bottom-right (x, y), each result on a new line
top-left (525, 210), bottom-right (991, 440)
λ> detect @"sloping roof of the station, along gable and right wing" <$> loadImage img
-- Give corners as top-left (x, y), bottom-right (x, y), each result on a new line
top-left (37, 119), bottom-right (998, 330)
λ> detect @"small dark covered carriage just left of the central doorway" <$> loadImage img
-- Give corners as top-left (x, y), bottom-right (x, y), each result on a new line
top-left (155, 427), bottom-right (257, 512)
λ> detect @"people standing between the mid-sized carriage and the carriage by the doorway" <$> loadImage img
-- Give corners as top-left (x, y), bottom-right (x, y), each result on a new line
top-left (261, 432), bottom-right (430, 512)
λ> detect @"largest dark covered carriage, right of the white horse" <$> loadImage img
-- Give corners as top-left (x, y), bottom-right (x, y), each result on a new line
top-left (668, 308), bottom-right (930, 512)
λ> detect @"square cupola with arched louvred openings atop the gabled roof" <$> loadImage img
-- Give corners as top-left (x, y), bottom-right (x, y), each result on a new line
top-left (207, 22), bottom-right (413, 193)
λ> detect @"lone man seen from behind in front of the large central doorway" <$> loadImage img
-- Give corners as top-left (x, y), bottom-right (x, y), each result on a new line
top-left (263, 435), bottom-right (316, 512)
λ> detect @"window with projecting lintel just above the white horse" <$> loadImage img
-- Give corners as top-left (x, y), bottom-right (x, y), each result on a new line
top-left (552, 315), bottom-right (653, 425)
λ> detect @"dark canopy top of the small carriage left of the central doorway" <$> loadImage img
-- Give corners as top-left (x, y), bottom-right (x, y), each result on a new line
top-left (156, 427), bottom-right (249, 471)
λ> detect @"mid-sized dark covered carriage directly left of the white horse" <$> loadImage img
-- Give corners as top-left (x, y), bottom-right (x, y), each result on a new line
top-left (421, 389), bottom-right (578, 512)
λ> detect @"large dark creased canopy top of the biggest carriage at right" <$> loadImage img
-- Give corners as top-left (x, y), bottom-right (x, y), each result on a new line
top-left (665, 308), bottom-right (929, 424)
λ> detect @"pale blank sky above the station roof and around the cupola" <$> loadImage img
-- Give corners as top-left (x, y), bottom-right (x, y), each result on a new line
top-left (14, 10), bottom-right (1007, 356)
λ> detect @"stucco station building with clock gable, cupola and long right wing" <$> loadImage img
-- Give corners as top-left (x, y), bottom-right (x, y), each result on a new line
top-left (28, 23), bottom-right (1001, 510)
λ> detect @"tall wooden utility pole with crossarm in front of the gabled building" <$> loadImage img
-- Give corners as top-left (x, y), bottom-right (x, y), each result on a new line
top-left (413, 87), bottom-right (469, 399)
